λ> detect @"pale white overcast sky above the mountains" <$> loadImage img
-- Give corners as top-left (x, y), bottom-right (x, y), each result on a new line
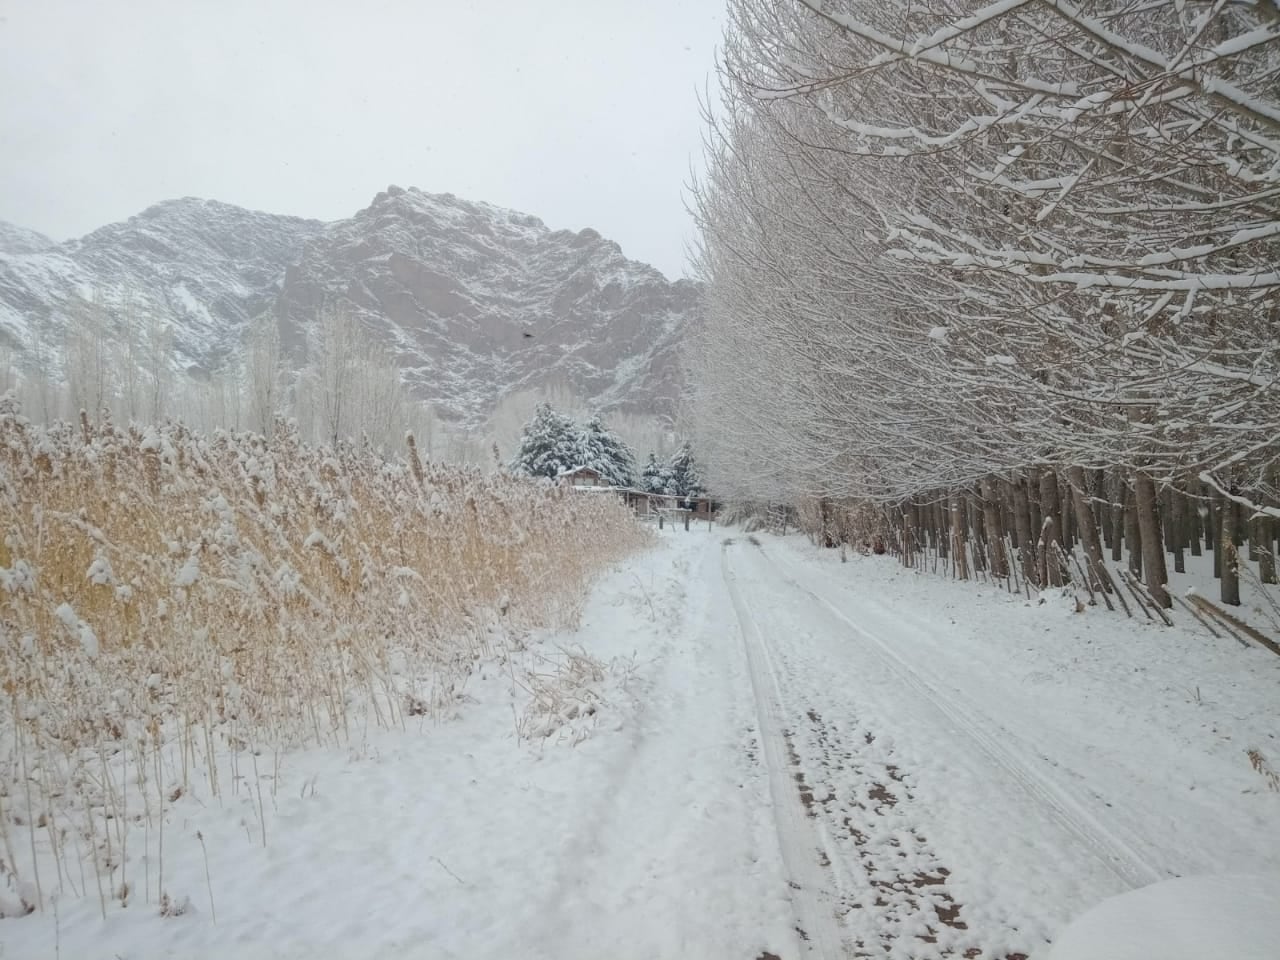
top-left (0, 0), bottom-right (723, 276)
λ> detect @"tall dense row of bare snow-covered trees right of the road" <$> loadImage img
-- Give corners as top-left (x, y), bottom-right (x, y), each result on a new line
top-left (689, 0), bottom-right (1280, 607)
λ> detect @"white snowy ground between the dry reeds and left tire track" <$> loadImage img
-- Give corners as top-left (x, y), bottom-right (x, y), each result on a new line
top-left (0, 530), bottom-right (795, 960)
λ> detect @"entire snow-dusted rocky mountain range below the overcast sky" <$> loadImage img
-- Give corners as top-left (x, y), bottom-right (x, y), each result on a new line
top-left (0, 187), bottom-right (700, 425)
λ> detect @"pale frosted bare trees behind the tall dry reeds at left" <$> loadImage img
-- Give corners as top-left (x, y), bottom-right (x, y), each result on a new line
top-left (0, 293), bottom-right (468, 460)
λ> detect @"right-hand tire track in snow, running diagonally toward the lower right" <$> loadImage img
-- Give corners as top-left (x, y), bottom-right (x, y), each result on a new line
top-left (760, 548), bottom-right (1166, 887)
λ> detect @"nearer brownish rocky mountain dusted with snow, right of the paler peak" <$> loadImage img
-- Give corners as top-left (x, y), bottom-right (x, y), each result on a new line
top-left (279, 187), bottom-right (700, 422)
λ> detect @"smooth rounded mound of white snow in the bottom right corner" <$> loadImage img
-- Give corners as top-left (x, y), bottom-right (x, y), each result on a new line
top-left (1047, 873), bottom-right (1280, 960)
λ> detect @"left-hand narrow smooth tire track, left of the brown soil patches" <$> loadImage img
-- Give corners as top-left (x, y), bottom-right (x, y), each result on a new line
top-left (721, 544), bottom-right (850, 960)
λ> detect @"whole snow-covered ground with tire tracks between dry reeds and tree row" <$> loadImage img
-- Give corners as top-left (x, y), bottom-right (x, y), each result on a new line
top-left (0, 526), bottom-right (1280, 960)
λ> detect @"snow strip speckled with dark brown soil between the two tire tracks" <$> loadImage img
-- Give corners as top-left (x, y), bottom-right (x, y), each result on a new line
top-left (724, 545), bottom-right (1027, 960)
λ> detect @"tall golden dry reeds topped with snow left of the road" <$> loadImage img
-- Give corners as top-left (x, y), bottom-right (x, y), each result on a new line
top-left (0, 399), bottom-right (646, 914)
